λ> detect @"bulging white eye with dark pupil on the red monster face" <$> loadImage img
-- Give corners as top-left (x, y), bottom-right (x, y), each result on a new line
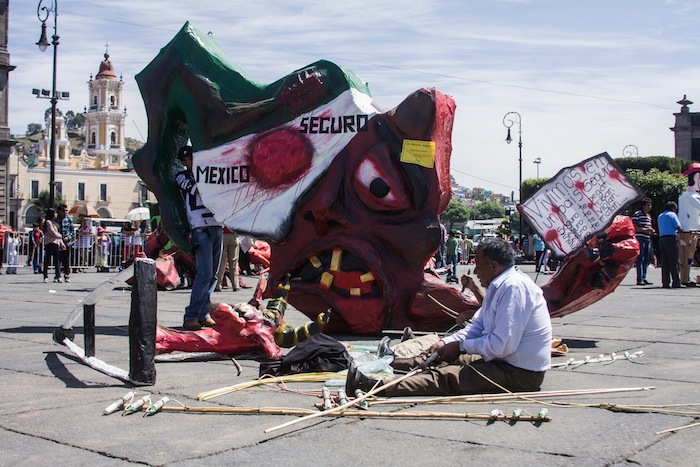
top-left (353, 150), bottom-right (409, 211)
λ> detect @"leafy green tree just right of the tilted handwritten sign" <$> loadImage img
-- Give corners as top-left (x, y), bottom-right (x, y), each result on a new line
top-left (621, 169), bottom-right (688, 221)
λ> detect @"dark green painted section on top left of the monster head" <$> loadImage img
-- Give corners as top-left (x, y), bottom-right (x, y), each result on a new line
top-left (133, 22), bottom-right (370, 252)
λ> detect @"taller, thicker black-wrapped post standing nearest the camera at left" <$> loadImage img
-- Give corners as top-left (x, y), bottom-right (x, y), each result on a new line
top-left (129, 258), bottom-right (158, 386)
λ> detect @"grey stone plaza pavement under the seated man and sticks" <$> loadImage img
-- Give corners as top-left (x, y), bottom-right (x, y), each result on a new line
top-left (0, 265), bottom-right (700, 466)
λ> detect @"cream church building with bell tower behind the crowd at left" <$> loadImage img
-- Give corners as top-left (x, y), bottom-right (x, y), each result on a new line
top-left (5, 54), bottom-right (150, 230)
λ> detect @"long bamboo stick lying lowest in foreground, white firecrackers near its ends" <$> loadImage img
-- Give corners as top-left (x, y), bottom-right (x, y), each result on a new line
top-left (150, 406), bottom-right (552, 424)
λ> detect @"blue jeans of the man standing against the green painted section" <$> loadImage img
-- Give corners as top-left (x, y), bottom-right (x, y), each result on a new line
top-left (185, 226), bottom-right (223, 321)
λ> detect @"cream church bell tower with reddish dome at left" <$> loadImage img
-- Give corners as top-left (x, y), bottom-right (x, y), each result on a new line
top-left (84, 53), bottom-right (127, 169)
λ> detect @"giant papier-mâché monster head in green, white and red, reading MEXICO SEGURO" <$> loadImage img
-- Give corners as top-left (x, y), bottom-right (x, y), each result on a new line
top-left (134, 24), bottom-right (474, 333)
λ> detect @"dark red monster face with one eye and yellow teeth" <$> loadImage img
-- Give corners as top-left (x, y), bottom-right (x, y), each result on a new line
top-left (270, 90), bottom-right (454, 334)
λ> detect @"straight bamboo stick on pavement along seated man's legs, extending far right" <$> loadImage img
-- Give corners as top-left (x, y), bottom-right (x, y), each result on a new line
top-left (369, 386), bottom-right (656, 405)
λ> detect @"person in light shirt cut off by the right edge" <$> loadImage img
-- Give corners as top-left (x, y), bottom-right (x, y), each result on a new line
top-left (678, 162), bottom-right (700, 287)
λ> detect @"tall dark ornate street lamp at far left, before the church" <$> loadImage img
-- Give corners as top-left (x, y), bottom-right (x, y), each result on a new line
top-left (32, 0), bottom-right (69, 208)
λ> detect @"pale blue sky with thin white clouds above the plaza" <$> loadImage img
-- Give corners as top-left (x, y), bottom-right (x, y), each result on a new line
top-left (8, 0), bottom-right (700, 194)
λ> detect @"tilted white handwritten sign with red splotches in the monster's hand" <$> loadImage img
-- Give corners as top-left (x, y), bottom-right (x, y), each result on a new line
top-left (518, 152), bottom-right (644, 257)
